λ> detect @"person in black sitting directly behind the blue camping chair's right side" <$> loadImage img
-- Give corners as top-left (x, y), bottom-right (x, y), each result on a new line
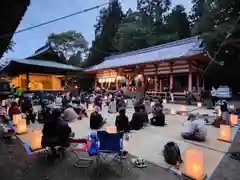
top-left (115, 108), bottom-right (130, 133)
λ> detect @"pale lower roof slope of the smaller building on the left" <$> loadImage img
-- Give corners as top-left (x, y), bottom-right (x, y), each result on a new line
top-left (9, 59), bottom-right (81, 70)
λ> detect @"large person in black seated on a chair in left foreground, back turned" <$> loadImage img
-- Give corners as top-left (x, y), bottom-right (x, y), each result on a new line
top-left (42, 108), bottom-right (74, 157)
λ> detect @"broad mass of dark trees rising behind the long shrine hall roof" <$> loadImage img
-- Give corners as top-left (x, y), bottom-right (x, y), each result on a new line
top-left (83, 0), bottom-right (190, 67)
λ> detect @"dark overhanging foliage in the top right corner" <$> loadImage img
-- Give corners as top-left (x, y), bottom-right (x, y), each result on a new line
top-left (192, 0), bottom-right (240, 55)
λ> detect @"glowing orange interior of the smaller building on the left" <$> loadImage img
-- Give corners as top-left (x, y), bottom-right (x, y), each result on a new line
top-left (11, 74), bottom-right (64, 91)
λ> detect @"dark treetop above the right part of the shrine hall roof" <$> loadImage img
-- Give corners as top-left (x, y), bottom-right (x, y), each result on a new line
top-left (166, 5), bottom-right (190, 39)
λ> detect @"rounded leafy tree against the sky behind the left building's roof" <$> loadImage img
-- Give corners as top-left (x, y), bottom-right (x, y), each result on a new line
top-left (47, 31), bottom-right (88, 60)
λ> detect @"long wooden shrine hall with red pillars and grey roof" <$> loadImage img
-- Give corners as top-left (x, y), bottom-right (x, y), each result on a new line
top-left (86, 37), bottom-right (210, 93)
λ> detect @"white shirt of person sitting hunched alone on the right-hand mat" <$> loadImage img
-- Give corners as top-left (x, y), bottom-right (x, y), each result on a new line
top-left (188, 119), bottom-right (207, 138)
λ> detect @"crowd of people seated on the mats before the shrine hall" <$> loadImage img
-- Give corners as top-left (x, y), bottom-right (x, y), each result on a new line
top-left (0, 87), bottom-right (235, 160)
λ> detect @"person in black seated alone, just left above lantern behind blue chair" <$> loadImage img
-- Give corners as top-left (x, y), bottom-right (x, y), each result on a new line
top-left (90, 106), bottom-right (106, 130)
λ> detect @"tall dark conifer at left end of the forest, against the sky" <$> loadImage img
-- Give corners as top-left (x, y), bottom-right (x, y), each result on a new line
top-left (83, 1), bottom-right (123, 67)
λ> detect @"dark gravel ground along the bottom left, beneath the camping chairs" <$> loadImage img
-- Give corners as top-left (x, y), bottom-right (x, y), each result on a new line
top-left (0, 136), bottom-right (179, 180)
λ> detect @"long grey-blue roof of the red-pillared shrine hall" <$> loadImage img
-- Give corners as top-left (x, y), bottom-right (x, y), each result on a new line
top-left (86, 37), bottom-right (204, 72)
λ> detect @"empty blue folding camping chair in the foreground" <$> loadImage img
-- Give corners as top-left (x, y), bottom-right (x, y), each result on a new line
top-left (96, 131), bottom-right (123, 177)
